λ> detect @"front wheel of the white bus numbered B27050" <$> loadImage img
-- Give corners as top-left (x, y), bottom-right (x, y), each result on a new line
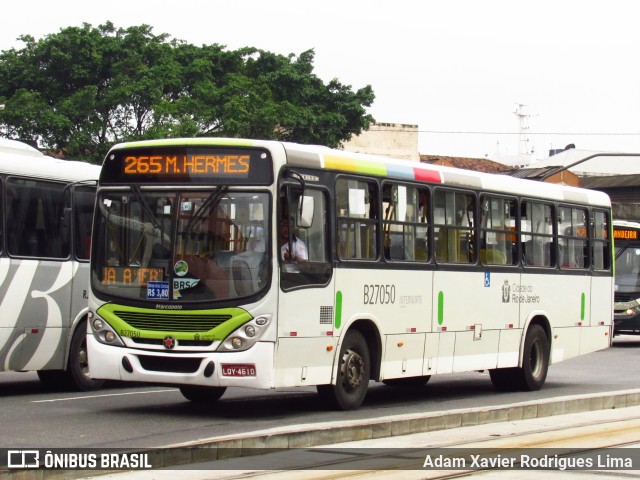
top-left (317, 330), bottom-right (371, 410)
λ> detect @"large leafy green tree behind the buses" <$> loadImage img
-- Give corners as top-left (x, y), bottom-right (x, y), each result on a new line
top-left (0, 22), bottom-right (375, 161)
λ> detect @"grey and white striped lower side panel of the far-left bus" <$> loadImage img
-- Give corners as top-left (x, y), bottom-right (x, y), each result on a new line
top-left (0, 260), bottom-right (73, 370)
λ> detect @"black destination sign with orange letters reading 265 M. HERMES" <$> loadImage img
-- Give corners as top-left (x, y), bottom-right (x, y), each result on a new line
top-left (100, 147), bottom-right (272, 185)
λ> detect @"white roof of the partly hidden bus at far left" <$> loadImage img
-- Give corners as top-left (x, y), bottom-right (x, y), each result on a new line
top-left (0, 139), bottom-right (100, 182)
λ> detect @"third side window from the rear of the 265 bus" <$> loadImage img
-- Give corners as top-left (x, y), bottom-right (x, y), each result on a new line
top-left (520, 201), bottom-right (556, 267)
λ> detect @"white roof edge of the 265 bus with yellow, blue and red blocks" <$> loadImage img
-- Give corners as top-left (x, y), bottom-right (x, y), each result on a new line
top-left (107, 138), bottom-right (611, 207)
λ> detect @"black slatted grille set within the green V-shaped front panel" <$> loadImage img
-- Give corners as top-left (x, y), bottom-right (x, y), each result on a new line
top-left (113, 311), bottom-right (231, 332)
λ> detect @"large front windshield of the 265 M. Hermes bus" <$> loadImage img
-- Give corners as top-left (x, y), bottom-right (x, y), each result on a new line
top-left (92, 187), bottom-right (269, 303)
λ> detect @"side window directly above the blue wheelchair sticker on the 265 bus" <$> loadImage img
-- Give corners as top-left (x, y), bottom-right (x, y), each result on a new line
top-left (480, 196), bottom-right (517, 265)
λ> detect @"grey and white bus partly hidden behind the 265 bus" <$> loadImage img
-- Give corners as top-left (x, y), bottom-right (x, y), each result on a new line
top-left (0, 139), bottom-right (102, 390)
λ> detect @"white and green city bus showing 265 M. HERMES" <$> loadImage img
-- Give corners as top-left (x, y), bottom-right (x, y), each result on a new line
top-left (87, 138), bottom-right (613, 409)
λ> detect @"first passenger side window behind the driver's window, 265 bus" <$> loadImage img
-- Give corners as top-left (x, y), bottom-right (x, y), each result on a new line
top-left (336, 178), bottom-right (378, 260)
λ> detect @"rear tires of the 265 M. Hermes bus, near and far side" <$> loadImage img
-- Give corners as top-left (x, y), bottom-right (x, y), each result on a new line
top-left (489, 324), bottom-right (550, 391)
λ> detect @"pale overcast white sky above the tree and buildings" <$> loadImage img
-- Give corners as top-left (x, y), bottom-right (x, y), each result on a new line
top-left (0, 0), bottom-right (640, 158)
